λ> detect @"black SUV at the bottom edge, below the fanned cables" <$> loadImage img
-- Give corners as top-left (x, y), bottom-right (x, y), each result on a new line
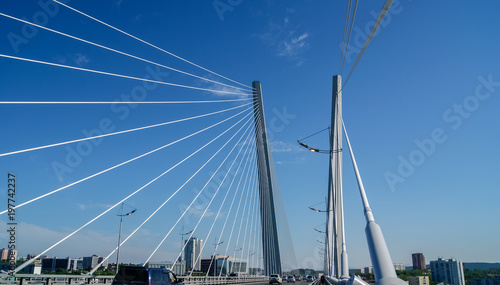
top-left (112, 265), bottom-right (184, 285)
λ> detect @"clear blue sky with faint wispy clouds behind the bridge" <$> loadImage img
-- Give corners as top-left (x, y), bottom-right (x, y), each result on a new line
top-left (0, 0), bottom-right (500, 268)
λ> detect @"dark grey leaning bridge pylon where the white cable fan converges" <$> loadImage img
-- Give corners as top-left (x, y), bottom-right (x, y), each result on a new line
top-left (252, 81), bottom-right (282, 276)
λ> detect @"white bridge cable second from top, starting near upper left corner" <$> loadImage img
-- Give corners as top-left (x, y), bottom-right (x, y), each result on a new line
top-left (0, 13), bottom-right (248, 91)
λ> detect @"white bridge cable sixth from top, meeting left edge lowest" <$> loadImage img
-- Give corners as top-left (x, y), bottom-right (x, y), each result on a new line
top-left (0, 107), bottom-right (252, 215)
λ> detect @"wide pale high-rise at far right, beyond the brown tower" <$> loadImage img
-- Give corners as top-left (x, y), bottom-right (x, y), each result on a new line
top-left (430, 258), bottom-right (465, 285)
